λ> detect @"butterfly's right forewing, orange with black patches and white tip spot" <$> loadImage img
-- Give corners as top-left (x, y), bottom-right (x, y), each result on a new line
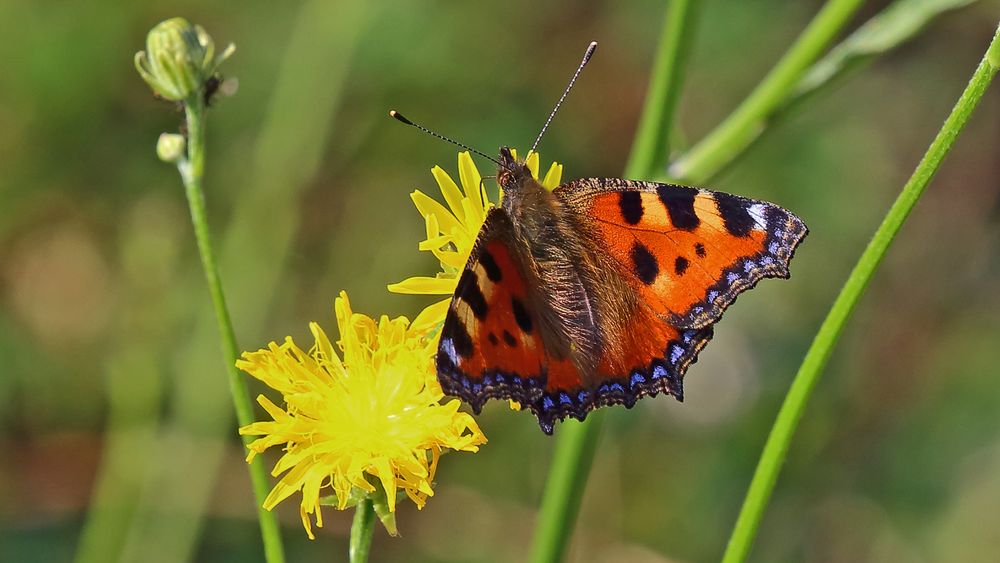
top-left (556, 179), bottom-right (808, 328)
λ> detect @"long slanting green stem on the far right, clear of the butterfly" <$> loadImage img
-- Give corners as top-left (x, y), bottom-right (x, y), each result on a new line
top-left (722, 22), bottom-right (1000, 563)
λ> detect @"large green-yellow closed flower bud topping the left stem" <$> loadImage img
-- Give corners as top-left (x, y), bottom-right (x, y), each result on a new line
top-left (135, 18), bottom-right (236, 101)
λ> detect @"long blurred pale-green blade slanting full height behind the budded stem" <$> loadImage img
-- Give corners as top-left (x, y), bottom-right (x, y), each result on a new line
top-left (114, 0), bottom-right (367, 561)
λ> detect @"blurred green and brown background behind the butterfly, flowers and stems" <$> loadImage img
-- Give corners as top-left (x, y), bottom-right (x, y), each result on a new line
top-left (0, 0), bottom-right (1000, 562)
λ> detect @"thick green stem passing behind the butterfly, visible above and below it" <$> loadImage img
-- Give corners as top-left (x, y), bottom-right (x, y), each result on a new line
top-left (530, 0), bottom-right (697, 563)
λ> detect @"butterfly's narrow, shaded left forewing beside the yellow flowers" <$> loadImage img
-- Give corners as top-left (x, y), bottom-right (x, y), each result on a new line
top-left (437, 209), bottom-right (545, 412)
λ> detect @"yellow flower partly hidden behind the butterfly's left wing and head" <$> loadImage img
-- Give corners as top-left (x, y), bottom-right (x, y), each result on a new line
top-left (389, 150), bottom-right (562, 330)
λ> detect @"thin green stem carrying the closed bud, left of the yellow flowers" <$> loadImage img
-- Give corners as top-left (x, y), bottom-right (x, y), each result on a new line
top-left (178, 93), bottom-right (285, 563)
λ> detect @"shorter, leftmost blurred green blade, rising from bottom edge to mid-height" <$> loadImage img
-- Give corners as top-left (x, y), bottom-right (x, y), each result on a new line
top-left (74, 204), bottom-right (181, 563)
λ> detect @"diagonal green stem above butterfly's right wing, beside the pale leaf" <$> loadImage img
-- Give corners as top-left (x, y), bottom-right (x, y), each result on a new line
top-left (670, 0), bottom-right (864, 184)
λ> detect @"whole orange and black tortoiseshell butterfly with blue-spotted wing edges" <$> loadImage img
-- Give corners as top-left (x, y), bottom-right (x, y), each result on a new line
top-left (391, 43), bottom-right (808, 434)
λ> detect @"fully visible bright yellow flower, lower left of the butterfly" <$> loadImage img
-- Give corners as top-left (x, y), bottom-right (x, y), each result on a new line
top-left (237, 292), bottom-right (486, 538)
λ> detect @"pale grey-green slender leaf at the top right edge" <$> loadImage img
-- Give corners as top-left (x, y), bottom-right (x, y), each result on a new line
top-left (778, 0), bottom-right (976, 111)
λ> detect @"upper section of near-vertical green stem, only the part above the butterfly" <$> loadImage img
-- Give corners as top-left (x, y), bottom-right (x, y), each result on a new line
top-left (625, 0), bottom-right (699, 178)
